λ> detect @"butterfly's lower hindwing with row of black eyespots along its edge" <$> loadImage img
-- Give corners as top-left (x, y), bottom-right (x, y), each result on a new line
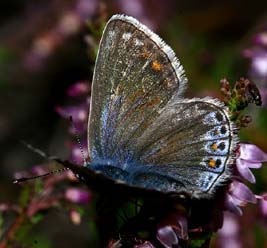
top-left (129, 98), bottom-right (236, 197)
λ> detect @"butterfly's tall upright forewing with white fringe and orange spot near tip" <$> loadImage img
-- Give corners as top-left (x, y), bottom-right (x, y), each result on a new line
top-left (88, 15), bottom-right (187, 166)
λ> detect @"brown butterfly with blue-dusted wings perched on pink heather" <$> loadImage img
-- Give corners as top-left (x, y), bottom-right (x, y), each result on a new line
top-left (59, 15), bottom-right (237, 198)
